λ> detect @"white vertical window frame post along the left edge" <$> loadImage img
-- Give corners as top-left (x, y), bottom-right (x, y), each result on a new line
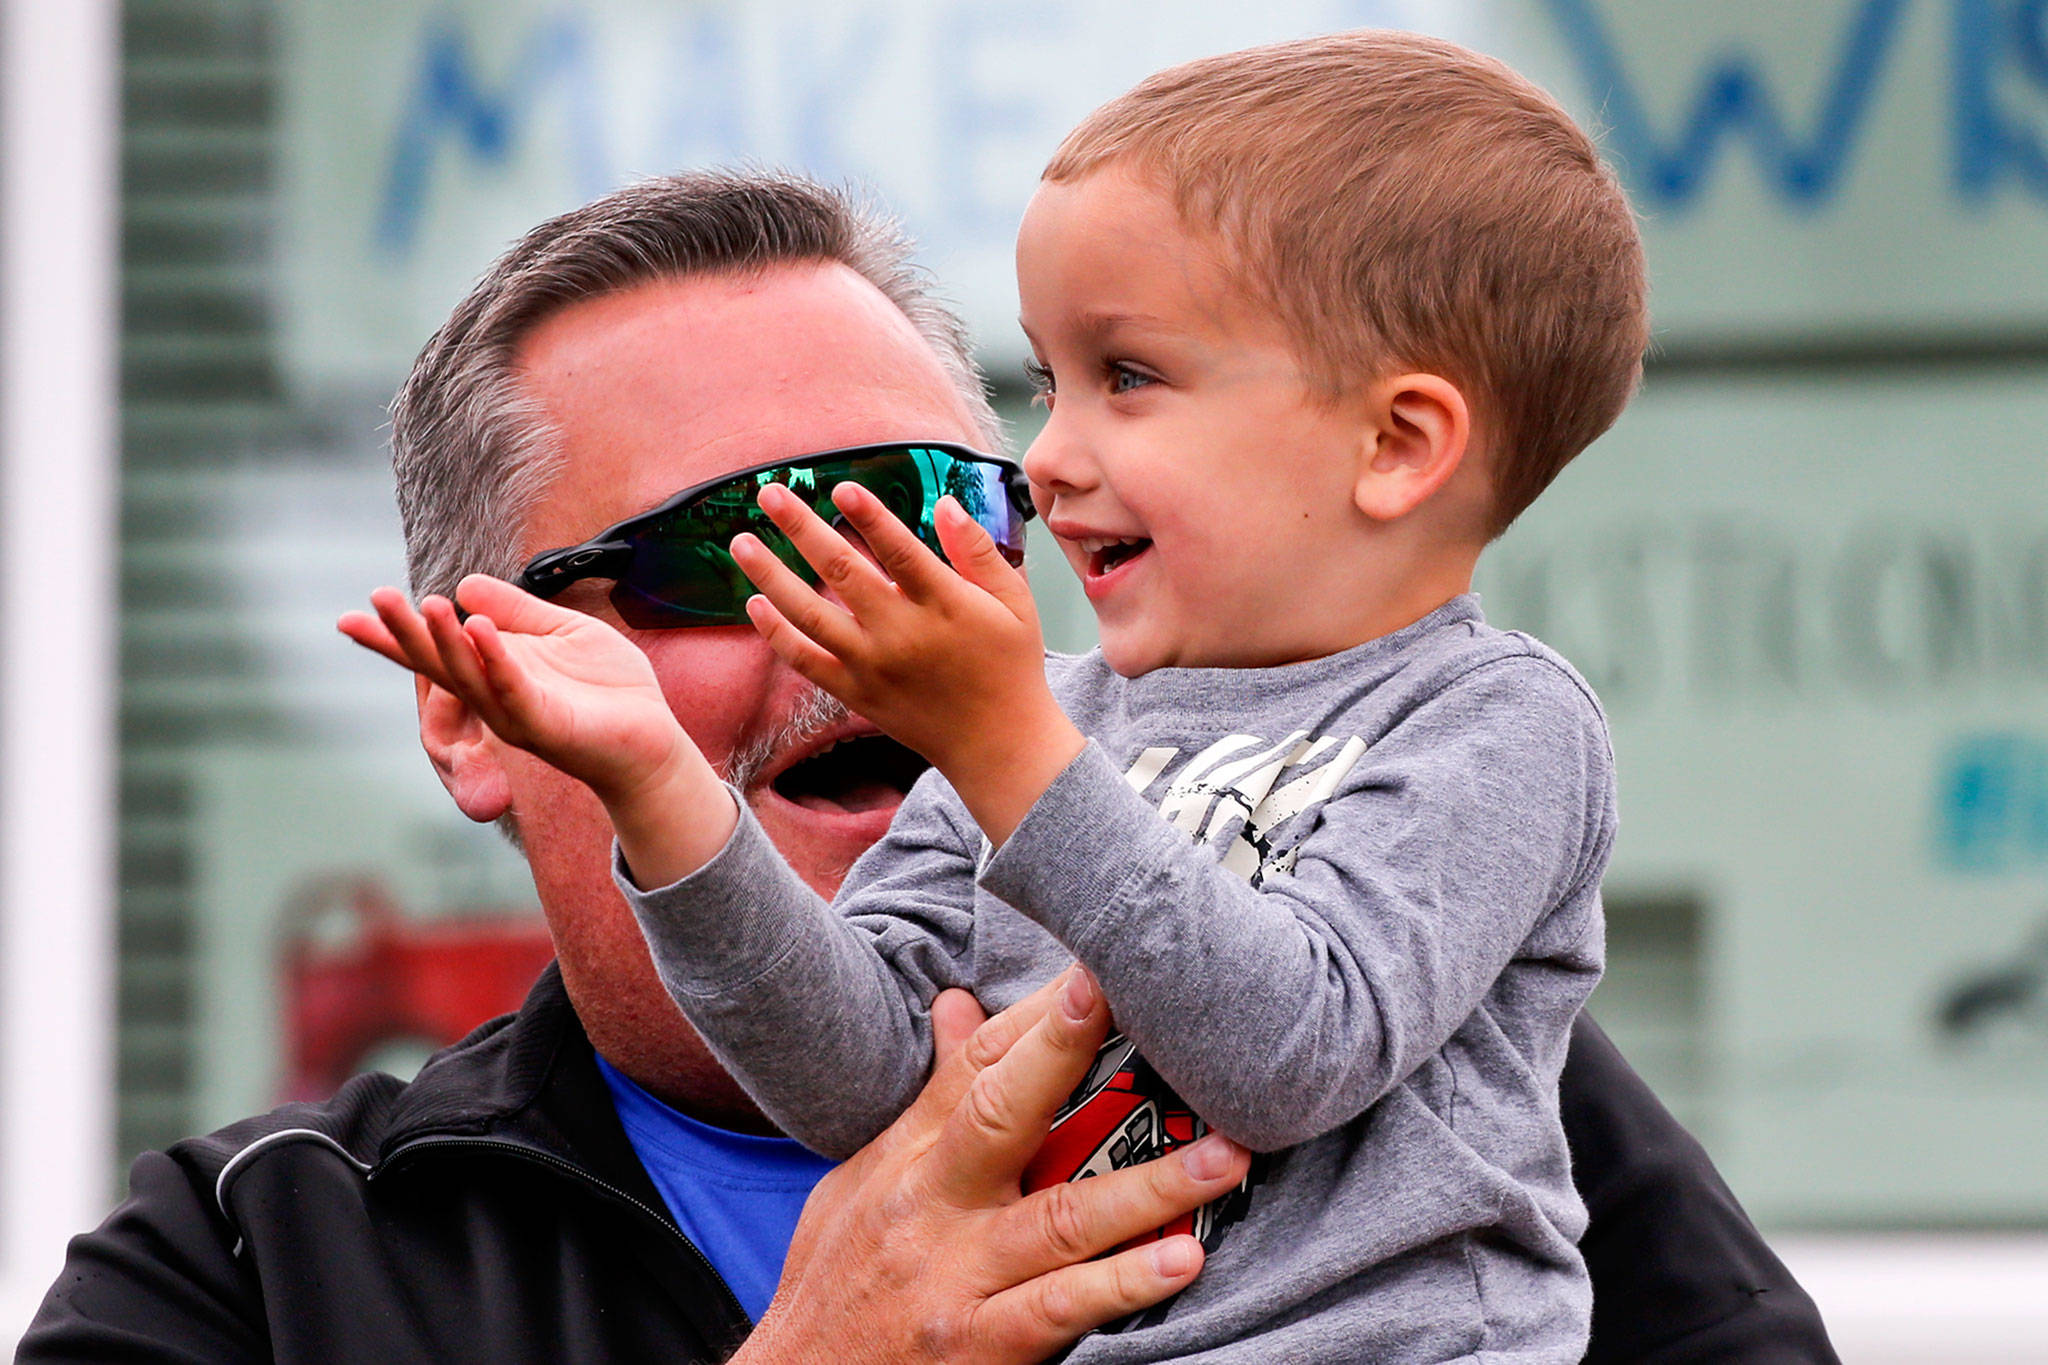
top-left (0, 0), bottom-right (121, 1338)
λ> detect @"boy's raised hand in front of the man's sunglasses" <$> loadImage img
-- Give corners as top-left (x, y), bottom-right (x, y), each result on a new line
top-left (733, 483), bottom-right (1085, 843)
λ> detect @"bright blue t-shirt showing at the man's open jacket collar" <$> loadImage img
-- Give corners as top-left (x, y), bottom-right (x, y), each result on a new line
top-left (598, 1056), bottom-right (834, 1322)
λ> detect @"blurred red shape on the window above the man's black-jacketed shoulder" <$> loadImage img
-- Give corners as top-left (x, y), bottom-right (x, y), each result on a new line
top-left (279, 876), bottom-right (555, 1099)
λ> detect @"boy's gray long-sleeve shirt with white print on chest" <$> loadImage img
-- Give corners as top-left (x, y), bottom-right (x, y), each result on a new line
top-left (621, 598), bottom-right (1614, 1361)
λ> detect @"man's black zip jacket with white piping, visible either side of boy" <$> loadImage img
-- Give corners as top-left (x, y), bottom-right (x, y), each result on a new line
top-left (16, 968), bottom-right (1835, 1365)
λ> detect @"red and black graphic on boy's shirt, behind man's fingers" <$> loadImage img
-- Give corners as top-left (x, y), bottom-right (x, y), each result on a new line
top-left (1024, 1033), bottom-right (1257, 1250)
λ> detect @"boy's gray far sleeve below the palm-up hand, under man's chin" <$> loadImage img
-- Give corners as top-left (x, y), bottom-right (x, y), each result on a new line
top-left (612, 774), bottom-right (979, 1158)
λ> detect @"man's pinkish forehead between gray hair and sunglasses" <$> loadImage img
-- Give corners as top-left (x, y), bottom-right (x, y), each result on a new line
top-left (503, 262), bottom-right (977, 548)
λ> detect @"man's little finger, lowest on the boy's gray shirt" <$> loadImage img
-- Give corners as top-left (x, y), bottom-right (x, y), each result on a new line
top-left (975, 1236), bottom-right (1202, 1361)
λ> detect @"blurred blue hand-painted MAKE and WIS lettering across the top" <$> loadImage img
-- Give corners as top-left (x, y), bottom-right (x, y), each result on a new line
top-left (375, 0), bottom-right (2048, 254)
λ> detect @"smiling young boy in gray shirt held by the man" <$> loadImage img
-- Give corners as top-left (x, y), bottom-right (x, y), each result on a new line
top-left (352, 33), bottom-right (1647, 1361)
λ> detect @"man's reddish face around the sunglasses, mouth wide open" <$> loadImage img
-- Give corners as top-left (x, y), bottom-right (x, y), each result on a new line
top-left (471, 264), bottom-right (979, 1055)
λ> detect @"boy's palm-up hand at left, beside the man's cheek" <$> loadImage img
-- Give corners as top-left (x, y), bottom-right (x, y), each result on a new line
top-left (336, 573), bottom-right (739, 886)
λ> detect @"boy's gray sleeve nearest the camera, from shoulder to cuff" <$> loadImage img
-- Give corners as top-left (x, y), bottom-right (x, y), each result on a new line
top-left (981, 657), bottom-right (1612, 1150)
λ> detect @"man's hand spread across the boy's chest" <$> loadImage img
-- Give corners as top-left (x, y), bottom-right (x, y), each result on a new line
top-left (733, 968), bottom-right (1249, 1365)
